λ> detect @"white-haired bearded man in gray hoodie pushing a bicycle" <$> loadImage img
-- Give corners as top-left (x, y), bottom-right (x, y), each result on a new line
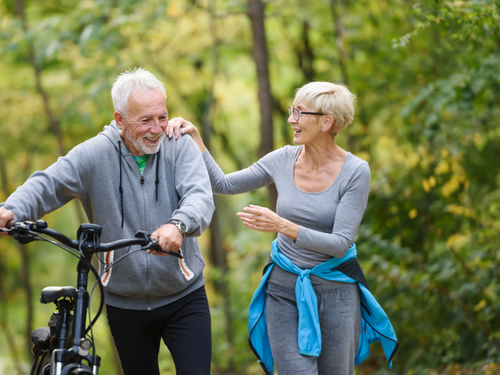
top-left (0, 69), bottom-right (214, 375)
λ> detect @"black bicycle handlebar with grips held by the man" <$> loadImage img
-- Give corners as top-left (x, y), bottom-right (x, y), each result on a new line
top-left (0, 220), bottom-right (183, 259)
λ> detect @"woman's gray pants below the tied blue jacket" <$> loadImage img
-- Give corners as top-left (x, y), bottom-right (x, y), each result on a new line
top-left (266, 265), bottom-right (361, 375)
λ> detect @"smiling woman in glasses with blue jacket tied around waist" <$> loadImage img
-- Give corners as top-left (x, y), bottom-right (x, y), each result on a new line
top-left (167, 82), bottom-right (398, 375)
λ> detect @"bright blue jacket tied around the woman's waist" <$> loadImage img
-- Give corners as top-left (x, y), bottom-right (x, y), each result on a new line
top-left (248, 240), bottom-right (399, 375)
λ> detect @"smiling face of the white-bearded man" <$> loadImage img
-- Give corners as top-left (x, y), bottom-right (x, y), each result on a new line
top-left (115, 90), bottom-right (168, 156)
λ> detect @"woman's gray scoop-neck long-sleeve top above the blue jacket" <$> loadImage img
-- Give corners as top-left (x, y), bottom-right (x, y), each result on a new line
top-left (203, 146), bottom-right (370, 268)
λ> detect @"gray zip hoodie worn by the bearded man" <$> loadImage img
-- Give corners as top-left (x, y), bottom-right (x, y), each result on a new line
top-left (0, 121), bottom-right (214, 310)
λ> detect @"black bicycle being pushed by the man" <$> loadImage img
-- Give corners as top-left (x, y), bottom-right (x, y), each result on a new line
top-left (0, 220), bottom-right (183, 375)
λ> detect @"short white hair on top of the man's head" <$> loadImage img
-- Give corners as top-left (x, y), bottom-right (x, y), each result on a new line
top-left (111, 67), bottom-right (167, 118)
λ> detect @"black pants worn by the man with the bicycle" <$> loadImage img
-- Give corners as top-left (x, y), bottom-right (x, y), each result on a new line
top-left (106, 287), bottom-right (212, 375)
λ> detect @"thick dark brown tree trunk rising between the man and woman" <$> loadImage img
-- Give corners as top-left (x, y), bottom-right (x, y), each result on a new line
top-left (248, 0), bottom-right (278, 211)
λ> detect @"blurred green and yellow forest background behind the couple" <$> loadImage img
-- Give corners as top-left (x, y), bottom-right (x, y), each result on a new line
top-left (0, 0), bottom-right (500, 375)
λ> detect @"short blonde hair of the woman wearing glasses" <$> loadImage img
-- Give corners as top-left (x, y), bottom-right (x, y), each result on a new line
top-left (293, 82), bottom-right (356, 136)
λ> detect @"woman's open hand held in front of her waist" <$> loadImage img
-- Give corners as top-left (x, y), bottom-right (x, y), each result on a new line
top-left (236, 204), bottom-right (299, 241)
